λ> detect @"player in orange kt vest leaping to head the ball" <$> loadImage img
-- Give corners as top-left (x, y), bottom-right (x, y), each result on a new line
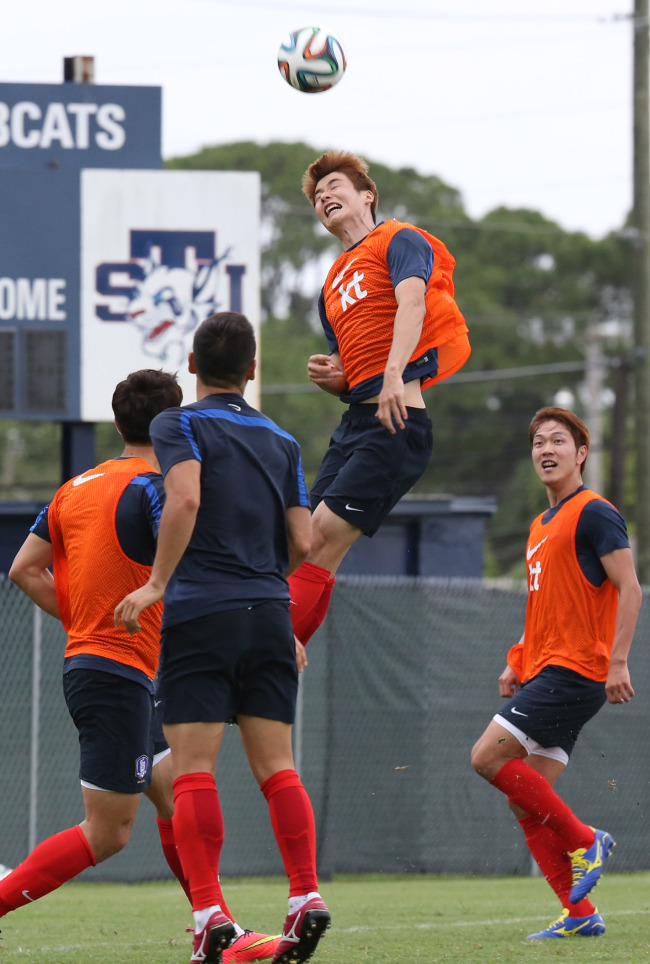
top-left (289, 151), bottom-right (470, 643)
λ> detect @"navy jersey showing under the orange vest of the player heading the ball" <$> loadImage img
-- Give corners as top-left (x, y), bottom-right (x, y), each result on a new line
top-left (318, 228), bottom-right (438, 404)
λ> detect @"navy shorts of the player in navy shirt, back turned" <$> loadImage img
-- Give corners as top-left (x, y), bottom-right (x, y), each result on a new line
top-left (156, 600), bottom-right (298, 723)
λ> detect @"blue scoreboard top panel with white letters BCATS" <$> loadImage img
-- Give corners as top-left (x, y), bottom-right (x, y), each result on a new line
top-left (0, 83), bottom-right (162, 170)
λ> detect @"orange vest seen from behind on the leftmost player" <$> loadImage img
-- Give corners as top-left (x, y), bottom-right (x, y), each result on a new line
top-left (48, 458), bottom-right (162, 679)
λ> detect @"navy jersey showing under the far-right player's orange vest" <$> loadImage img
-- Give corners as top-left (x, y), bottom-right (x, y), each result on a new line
top-left (542, 485), bottom-right (630, 586)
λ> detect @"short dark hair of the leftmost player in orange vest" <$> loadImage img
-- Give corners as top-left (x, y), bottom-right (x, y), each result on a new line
top-left (111, 368), bottom-right (183, 445)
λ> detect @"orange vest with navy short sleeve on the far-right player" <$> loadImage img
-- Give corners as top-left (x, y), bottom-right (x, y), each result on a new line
top-left (508, 486), bottom-right (630, 681)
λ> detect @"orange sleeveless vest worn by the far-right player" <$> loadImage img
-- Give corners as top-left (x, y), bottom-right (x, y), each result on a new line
top-left (508, 489), bottom-right (618, 682)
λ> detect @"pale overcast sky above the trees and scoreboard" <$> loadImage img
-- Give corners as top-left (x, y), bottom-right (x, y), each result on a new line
top-left (0, 0), bottom-right (633, 237)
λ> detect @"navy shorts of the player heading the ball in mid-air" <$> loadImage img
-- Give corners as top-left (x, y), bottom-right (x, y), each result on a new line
top-left (310, 404), bottom-right (433, 536)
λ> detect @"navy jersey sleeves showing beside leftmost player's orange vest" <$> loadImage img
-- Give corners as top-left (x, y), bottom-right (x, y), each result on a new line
top-left (29, 460), bottom-right (165, 566)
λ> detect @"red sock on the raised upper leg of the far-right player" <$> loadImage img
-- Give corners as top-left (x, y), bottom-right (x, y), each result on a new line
top-left (490, 760), bottom-right (595, 850)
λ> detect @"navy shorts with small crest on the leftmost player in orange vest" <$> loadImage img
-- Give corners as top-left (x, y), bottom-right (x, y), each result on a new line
top-left (63, 669), bottom-right (154, 793)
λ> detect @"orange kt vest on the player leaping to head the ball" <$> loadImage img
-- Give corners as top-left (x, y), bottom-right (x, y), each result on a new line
top-left (323, 219), bottom-right (471, 388)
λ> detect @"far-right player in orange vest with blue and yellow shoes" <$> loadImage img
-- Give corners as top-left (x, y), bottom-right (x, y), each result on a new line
top-left (472, 407), bottom-right (641, 939)
